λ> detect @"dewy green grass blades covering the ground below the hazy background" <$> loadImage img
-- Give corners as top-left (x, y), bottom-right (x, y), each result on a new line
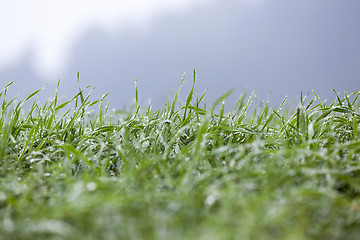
top-left (0, 73), bottom-right (360, 240)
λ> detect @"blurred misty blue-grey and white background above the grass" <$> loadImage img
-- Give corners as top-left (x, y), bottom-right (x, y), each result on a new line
top-left (0, 0), bottom-right (360, 108)
